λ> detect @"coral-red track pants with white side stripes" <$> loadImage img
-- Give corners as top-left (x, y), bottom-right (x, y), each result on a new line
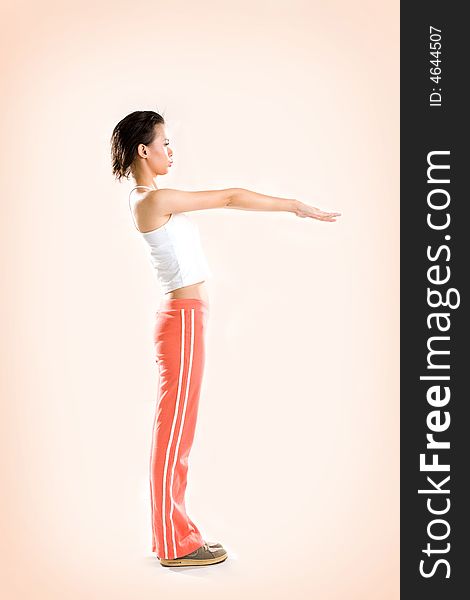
top-left (150, 298), bottom-right (209, 559)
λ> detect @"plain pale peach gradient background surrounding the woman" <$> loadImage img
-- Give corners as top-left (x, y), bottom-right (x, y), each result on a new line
top-left (0, 0), bottom-right (399, 600)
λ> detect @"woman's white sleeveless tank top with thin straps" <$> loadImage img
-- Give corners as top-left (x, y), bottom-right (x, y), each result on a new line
top-left (129, 185), bottom-right (212, 294)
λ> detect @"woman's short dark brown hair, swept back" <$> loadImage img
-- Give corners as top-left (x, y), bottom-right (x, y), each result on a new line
top-left (111, 110), bottom-right (165, 181)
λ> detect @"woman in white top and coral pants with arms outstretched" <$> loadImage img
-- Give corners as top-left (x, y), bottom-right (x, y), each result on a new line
top-left (111, 111), bottom-right (340, 566)
